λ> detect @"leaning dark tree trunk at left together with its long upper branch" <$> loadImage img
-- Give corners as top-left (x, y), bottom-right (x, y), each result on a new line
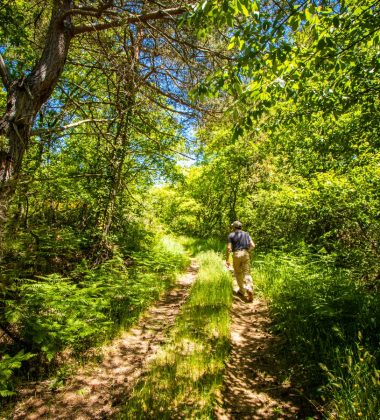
top-left (0, 0), bottom-right (186, 226)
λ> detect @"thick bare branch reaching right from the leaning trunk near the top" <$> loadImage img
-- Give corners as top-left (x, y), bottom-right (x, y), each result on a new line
top-left (72, 7), bottom-right (187, 36)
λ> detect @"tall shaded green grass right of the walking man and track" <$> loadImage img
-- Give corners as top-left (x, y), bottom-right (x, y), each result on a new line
top-left (253, 255), bottom-right (380, 419)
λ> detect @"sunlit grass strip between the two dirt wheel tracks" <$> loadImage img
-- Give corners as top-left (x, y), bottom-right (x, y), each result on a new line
top-left (121, 252), bottom-right (232, 419)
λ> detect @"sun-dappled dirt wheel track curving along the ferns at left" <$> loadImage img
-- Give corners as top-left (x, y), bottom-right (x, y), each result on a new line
top-left (12, 261), bottom-right (197, 420)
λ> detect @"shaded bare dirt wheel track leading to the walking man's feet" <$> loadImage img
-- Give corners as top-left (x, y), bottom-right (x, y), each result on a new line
top-left (216, 296), bottom-right (312, 420)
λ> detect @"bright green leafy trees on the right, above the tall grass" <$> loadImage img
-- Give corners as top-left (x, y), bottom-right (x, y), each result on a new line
top-left (157, 0), bottom-right (380, 283)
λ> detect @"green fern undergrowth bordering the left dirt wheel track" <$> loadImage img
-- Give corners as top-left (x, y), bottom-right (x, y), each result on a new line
top-left (0, 236), bottom-right (189, 402)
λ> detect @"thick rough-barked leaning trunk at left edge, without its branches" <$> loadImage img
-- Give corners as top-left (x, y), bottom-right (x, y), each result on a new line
top-left (0, 0), bottom-right (73, 215)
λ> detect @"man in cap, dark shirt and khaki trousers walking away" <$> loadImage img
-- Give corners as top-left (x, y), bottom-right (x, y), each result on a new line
top-left (226, 220), bottom-right (255, 302)
